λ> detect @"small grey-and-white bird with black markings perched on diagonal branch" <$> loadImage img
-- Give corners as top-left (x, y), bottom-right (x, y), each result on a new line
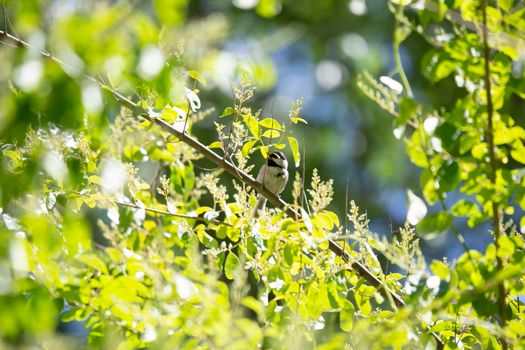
top-left (253, 151), bottom-right (289, 218)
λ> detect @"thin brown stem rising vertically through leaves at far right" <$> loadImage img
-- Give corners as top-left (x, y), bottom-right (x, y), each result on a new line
top-left (482, 0), bottom-right (508, 350)
